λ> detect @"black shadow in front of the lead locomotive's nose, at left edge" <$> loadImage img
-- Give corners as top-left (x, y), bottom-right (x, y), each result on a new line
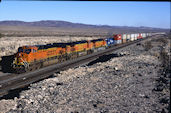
top-left (0, 55), bottom-right (14, 73)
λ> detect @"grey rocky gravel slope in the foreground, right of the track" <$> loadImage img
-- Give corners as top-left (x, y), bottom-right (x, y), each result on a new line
top-left (0, 34), bottom-right (170, 113)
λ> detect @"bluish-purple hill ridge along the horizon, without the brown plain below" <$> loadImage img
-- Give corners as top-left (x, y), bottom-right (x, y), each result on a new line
top-left (0, 20), bottom-right (168, 29)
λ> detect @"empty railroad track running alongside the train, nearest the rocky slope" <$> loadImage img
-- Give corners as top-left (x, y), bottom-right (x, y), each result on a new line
top-left (0, 37), bottom-right (162, 97)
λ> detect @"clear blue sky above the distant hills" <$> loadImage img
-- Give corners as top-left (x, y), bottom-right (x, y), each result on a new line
top-left (0, 0), bottom-right (171, 29)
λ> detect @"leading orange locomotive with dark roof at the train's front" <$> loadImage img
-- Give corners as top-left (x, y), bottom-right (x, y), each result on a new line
top-left (13, 45), bottom-right (66, 73)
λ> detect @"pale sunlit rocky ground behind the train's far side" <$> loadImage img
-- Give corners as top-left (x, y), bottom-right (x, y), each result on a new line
top-left (0, 36), bottom-right (100, 60)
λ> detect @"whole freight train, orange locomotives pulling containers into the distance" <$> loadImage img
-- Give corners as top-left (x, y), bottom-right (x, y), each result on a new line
top-left (12, 33), bottom-right (164, 73)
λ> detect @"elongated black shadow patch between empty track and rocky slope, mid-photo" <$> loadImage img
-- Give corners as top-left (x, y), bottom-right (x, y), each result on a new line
top-left (87, 53), bottom-right (125, 66)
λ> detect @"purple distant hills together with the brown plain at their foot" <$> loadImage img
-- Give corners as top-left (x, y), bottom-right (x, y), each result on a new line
top-left (0, 20), bottom-right (169, 36)
